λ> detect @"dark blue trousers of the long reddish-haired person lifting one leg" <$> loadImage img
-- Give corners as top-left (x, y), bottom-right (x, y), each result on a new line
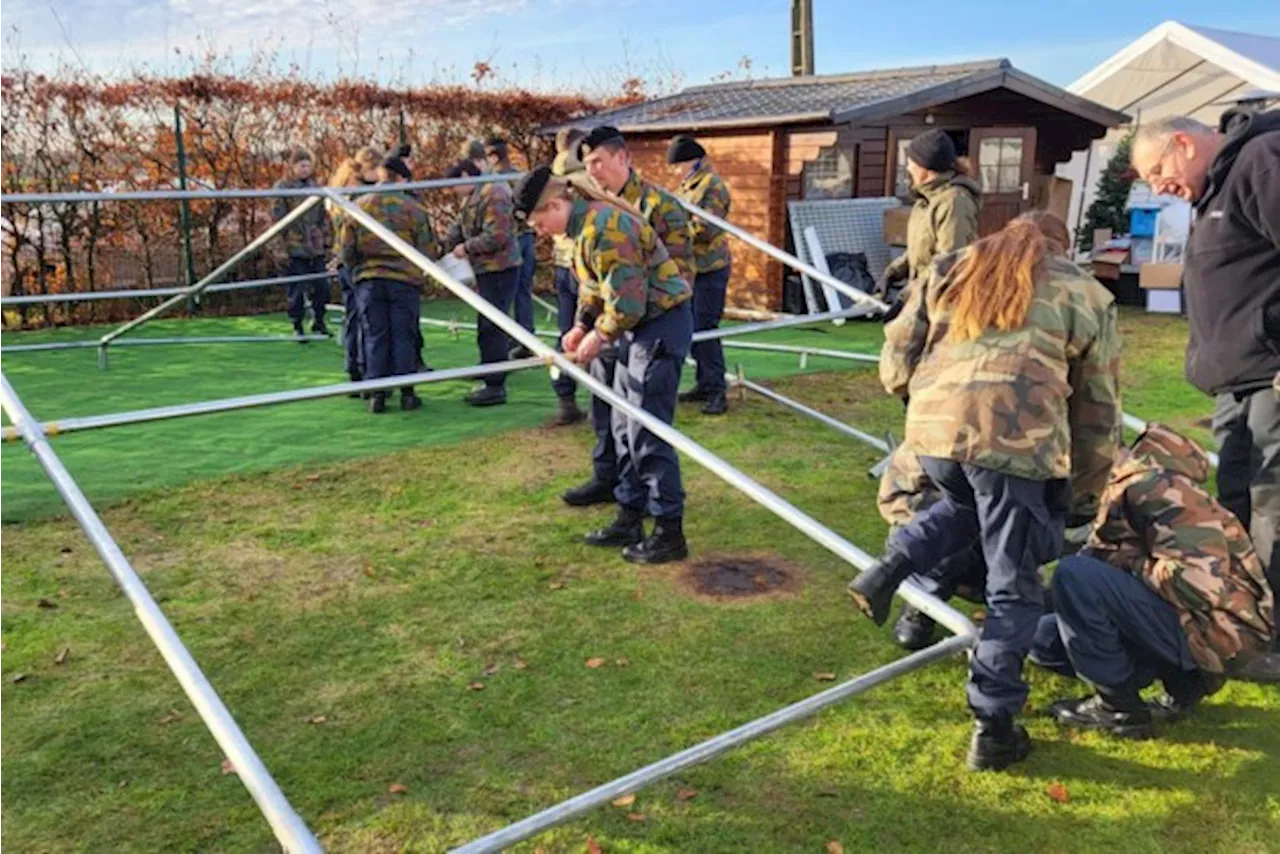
top-left (888, 457), bottom-right (1070, 718)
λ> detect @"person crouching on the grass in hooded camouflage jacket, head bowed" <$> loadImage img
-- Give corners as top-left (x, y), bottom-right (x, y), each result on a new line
top-left (1029, 424), bottom-right (1280, 739)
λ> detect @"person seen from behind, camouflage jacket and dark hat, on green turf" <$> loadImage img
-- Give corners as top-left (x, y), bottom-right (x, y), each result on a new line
top-left (338, 157), bottom-right (440, 414)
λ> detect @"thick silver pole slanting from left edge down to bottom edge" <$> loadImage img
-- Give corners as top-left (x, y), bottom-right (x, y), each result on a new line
top-left (0, 374), bottom-right (321, 854)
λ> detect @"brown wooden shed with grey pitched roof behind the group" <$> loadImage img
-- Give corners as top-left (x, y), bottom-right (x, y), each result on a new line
top-left (560, 59), bottom-right (1126, 310)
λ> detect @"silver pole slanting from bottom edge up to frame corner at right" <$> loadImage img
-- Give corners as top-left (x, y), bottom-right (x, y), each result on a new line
top-left (452, 635), bottom-right (972, 854)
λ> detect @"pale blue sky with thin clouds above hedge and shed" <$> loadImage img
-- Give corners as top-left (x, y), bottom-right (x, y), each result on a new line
top-left (0, 0), bottom-right (1280, 90)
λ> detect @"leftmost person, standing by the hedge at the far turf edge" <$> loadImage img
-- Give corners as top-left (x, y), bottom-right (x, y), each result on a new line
top-left (271, 149), bottom-right (333, 335)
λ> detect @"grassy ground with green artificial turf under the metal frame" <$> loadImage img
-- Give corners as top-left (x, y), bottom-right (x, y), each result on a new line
top-left (0, 306), bottom-right (1280, 854)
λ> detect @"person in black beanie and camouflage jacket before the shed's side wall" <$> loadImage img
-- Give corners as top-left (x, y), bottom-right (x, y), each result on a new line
top-left (667, 136), bottom-right (732, 415)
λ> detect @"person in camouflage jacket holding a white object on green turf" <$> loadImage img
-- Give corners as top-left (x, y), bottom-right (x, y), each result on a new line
top-left (444, 159), bottom-right (521, 406)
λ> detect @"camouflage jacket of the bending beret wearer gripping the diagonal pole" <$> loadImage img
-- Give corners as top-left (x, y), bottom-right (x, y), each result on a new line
top-left (568, 200), bottom-right (692, 341)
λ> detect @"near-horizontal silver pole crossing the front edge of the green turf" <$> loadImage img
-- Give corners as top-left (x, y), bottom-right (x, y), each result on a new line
top-left (0, 357), bottom-right (547, 442)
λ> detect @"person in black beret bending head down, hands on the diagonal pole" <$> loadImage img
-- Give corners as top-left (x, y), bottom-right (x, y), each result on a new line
top-left (516, 166), bottom-right (694, 563)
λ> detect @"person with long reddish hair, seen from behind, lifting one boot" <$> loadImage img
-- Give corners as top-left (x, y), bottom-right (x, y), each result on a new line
top-left (849, 214), bottom-right (1120, 771)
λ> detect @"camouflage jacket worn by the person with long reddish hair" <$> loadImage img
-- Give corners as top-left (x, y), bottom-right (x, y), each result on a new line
top-left (879, 255), bottom-right (1121, 515)
